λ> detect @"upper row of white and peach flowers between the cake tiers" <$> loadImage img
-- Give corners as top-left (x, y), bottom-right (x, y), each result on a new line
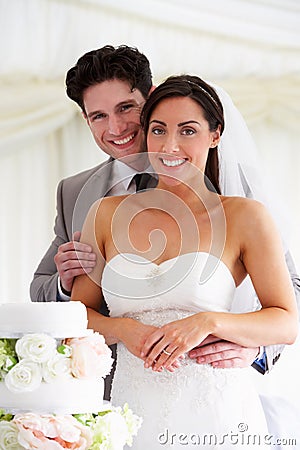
top-left (0, 333), bottom-right (113, 393)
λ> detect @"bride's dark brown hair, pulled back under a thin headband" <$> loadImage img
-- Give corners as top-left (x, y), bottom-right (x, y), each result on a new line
top-left (141, 75), bottom-right (225, 194)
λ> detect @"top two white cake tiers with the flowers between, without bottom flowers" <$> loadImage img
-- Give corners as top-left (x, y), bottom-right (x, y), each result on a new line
top-left (0, 302), bottom-right (107, 414)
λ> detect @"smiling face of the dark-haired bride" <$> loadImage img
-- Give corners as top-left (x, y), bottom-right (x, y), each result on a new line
top-left (147, 97), bottom-right (220, 184)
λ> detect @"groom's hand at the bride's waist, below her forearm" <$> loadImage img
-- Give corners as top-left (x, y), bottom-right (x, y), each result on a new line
top-left (189, 336), bottom-right (259, 369)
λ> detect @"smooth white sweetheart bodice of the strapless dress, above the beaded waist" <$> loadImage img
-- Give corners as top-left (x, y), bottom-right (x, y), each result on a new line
top-left (101, 252), bottom-right (236, 321)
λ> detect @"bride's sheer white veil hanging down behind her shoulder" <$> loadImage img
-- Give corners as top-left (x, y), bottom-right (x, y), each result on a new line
top-left (212, 84), bottom-right (287, 312)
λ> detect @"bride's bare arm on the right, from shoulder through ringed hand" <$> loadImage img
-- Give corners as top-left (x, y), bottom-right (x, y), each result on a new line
top-left (142, 200), bottom-right (298, 367)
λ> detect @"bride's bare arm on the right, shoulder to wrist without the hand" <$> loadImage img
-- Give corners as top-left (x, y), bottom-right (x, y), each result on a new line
top-left (214, 199), bottom-right (298, 347)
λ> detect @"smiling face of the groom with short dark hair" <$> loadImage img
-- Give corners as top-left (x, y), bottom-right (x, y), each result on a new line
top-left (83, 79), bottom-right (145, 162)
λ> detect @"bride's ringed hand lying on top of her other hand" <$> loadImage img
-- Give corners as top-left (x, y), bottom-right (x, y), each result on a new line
top-left (141, 313), bottom-right (212, 370)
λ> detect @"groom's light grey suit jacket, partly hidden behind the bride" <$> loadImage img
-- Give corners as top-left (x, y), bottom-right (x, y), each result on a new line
top-left (30, 159), bottom-right (300, 373)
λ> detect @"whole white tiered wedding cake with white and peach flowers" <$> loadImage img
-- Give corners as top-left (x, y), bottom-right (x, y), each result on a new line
top-left (0, 302), bottom-right (140, 450)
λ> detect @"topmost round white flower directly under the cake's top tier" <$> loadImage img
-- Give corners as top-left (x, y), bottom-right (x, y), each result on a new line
top-left (16, 333), bottom-right (56, 363)
